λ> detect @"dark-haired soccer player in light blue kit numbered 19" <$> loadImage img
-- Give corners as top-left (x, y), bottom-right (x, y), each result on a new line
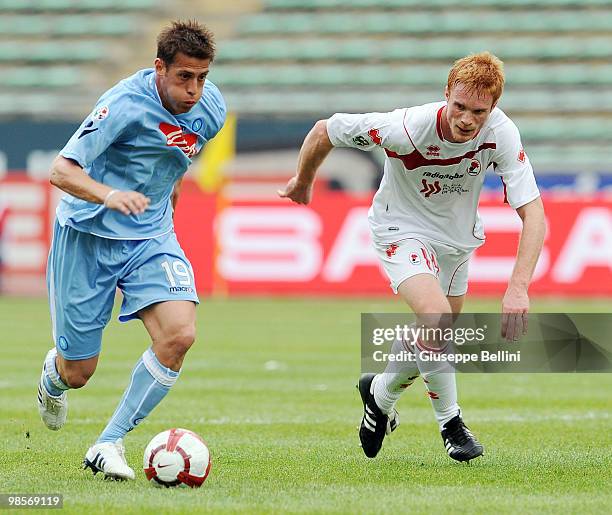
top-left (38, 21), bottom-right (226, 479)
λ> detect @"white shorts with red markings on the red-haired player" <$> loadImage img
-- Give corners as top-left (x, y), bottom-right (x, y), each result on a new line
top-left (374, 238), bottom-right (473, 297)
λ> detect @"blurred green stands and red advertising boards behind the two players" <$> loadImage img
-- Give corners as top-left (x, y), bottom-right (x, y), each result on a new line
top-left (0, 0), bottom-right (612, 296)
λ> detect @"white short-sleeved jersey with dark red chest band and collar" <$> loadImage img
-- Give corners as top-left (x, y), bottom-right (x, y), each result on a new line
top-left (327, 102), bottom-right (540, 251)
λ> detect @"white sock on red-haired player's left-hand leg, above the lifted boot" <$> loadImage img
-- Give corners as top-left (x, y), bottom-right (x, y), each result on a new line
top-left (372, 340), bottom-right (419, 415)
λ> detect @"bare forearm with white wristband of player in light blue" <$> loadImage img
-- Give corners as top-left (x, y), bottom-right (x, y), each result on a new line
top-left (49, 156), bottom-right (150, 215)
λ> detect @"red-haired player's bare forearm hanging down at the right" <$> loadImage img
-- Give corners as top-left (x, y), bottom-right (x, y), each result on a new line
top-left (502, 197), bottom-right (546, 340)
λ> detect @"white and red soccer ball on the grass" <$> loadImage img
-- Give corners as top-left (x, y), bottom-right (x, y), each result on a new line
top-left (143, 428), bottom-right (211, 488)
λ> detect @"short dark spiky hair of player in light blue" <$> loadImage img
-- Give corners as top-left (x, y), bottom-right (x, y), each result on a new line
top-left (157, 20), bottom-right (215, 65)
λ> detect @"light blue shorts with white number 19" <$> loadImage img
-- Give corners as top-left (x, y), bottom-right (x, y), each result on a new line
top-left (47, 220), bottom-right (199, 360)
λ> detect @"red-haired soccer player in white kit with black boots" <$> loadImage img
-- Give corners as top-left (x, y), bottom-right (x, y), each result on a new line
top-left (279, 52), bottom-right (546, 461)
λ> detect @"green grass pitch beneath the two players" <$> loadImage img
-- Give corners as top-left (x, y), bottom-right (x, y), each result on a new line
top-left (0, 298), bottom-right (612, 514)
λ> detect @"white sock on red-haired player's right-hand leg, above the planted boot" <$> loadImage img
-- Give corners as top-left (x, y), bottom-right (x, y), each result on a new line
top-left (415, 341), bottom-right (459, 429)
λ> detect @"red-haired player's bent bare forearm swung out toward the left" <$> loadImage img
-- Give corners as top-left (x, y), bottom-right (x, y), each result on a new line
top-left (278, 120), bottom-right (334, 205)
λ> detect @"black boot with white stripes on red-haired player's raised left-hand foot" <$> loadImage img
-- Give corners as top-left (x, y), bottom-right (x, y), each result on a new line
top-left (357, 374), bottom-right (399, 458)
